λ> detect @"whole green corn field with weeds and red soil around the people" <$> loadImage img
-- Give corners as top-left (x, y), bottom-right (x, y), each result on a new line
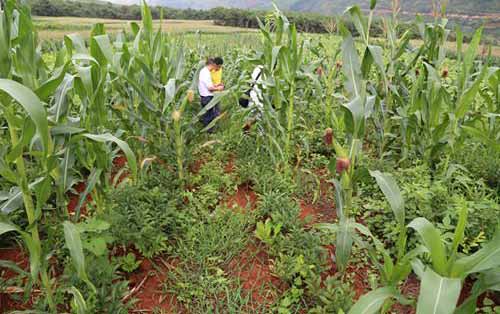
top-left (0, 0), bottom-right (500, 314)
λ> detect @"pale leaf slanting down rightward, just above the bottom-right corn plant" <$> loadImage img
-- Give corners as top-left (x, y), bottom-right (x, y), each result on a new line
top-left (370, 171), bottom-right (405, 225)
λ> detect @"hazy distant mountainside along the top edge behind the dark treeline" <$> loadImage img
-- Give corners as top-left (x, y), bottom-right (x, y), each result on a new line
top-left (111, 0), bottom-right (500, 15)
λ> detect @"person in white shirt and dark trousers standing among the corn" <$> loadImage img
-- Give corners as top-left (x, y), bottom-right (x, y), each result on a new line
top-left (198, 57), bottom-right (224, 132)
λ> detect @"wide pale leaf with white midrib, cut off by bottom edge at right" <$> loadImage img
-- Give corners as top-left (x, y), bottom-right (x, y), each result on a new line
top-left (417, 268), bottom-right (462, 314)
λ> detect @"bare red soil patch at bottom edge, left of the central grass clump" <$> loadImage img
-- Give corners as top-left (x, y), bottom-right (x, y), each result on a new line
top-left (129, 258), bottom-right (184, 313)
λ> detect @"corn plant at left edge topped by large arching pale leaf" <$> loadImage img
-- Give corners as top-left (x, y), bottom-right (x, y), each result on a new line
top-left (0, 79), bottom-right (55, 311)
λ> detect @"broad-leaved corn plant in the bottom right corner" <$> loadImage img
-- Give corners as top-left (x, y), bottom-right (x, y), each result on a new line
top-left (408, 206), bottom-right (500, 314)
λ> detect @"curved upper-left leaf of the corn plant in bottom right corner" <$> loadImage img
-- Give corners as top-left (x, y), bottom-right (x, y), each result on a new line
top-left (408, 217), bottom-right (447, 274)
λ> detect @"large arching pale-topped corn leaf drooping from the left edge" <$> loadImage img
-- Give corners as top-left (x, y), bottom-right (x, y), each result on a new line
top-left (0, 79), bottom-right (49, 153)
